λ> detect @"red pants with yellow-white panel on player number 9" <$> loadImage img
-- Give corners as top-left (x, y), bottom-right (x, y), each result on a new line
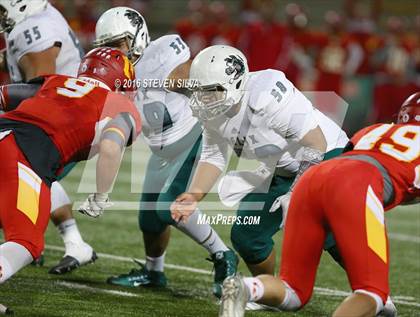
top-left (0, 134), bottom-right (51, 259)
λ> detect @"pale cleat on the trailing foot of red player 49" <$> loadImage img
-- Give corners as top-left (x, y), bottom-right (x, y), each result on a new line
top-left (219, 275), bottom-right (249, 317)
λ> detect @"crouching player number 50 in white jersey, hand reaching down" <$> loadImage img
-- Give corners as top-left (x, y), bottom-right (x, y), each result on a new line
top-left (171, 45), bottom-right (348, 292)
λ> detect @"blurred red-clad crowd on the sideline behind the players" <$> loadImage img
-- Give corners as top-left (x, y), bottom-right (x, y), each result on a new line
top-left (0, 0), bottom-right (420, 135)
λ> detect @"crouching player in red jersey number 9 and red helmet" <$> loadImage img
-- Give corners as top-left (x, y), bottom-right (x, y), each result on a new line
top-left (0, 48), bottom-right (141, 308)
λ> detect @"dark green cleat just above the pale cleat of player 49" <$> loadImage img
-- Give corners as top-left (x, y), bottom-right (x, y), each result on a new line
top-left (207, 249), bottom-right (239, 298)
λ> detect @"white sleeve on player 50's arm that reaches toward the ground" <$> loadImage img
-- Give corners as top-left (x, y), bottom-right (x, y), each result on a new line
top-left (200, 129), bottom-right (228, 171)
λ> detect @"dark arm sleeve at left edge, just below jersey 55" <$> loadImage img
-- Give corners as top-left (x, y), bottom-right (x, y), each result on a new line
top-left (0, 84), bottom-right (41, 112)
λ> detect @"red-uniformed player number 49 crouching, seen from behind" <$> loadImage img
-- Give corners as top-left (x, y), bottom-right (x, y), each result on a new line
top-left (219, 92), bottom-right (420, 317)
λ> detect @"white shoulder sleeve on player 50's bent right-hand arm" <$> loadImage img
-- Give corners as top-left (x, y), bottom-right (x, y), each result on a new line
top-left (266, 88), bottom-right (318, 142)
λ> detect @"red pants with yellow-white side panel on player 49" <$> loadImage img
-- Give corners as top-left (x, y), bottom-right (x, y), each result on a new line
top-left (280, 159), bottom-right (389, 306)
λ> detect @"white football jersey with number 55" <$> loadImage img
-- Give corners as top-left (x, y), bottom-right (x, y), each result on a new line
top-left (6, 3), bottom-right (84, 82)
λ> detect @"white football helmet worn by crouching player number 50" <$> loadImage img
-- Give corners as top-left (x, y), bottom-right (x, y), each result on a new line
top-left (190, 45), bottom-right (249, 121)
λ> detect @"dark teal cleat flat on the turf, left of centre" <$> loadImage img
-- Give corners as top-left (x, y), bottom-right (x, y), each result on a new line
top-left (106, 259), bottom-right (167, 287)
